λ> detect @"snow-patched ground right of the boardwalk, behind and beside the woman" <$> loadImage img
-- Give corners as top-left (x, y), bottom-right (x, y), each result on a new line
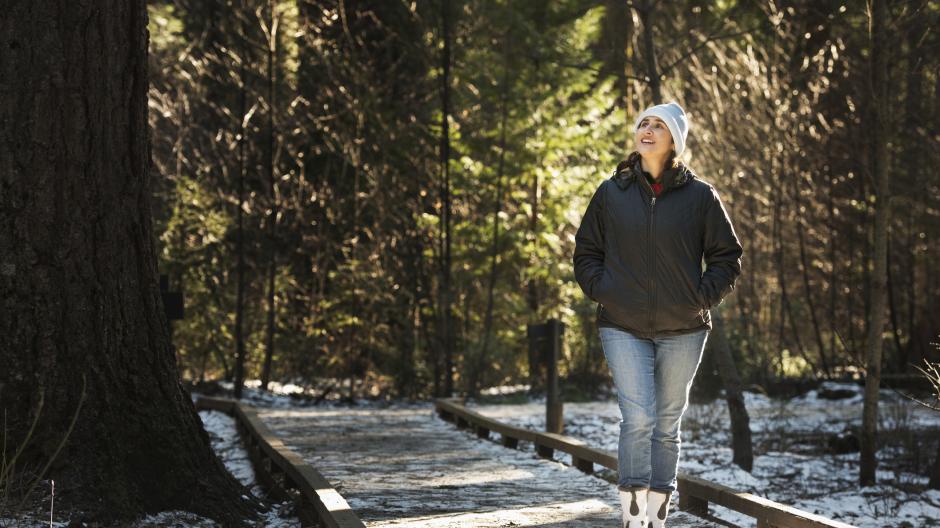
top-left (473, 383), bottom-right (940, 528)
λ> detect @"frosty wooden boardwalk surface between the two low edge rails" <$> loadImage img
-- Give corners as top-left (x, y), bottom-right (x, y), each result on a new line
top-left (258, 404), bottom-right (718, 528)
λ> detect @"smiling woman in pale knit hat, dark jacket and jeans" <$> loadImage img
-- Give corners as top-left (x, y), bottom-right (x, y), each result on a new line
top-left (574, 102), bottom-right (742, 528)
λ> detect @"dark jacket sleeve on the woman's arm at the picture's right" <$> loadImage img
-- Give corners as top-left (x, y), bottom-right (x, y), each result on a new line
top-left (699, 187), bottom-right (744, 309)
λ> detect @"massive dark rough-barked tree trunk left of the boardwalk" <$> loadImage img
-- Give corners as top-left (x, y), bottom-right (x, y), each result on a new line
top-left (0, 0), bottom-right (251, 525)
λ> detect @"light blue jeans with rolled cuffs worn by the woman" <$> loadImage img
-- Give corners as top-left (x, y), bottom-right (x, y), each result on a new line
top-left (599, 327), bottom-right (708, 491)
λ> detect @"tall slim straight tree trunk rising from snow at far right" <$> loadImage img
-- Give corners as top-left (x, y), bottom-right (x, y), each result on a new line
top-left (859, 0), bottom-right (891, 486)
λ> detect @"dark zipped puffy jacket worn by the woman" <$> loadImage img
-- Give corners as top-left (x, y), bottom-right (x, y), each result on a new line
top-left (574, 162), bottom-right (742, 338)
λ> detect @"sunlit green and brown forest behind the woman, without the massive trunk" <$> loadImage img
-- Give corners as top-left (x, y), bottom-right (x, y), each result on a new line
top-left (148, 0), bottom-right (940, 398)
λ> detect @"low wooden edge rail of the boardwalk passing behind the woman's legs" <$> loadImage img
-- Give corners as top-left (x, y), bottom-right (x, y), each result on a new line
top-left (434, 399), bottom-right (856, 528)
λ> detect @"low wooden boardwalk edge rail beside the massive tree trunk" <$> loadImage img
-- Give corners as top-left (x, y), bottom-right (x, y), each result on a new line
top-left (196, 396), bottom-right (365, 528)
